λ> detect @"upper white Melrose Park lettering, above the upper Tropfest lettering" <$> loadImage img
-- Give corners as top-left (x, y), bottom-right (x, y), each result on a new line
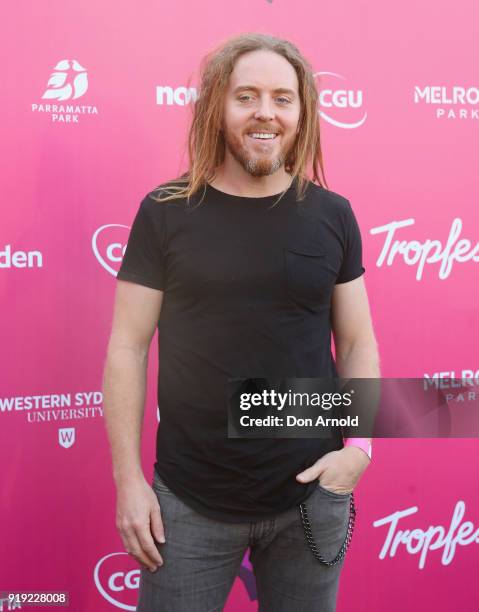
top-left (413, 85), bottom-right (479, 121)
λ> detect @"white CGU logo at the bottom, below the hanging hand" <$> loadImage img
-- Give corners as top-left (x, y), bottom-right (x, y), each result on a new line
top-left (93, 552), bottom-right (140, 611)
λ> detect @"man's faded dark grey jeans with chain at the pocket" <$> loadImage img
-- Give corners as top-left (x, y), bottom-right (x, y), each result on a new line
top-left (137, 472), bottom-right (350, 612)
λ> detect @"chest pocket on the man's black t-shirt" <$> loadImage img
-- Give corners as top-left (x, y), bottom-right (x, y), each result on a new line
top-left (284, 247), bottom-right (334, 308)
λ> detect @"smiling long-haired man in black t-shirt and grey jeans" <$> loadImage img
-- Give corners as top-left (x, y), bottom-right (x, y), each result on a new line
top-left (104, 34), bottom-right (379, 612)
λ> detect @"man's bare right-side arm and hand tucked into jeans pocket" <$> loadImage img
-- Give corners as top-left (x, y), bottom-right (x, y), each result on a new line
top-left (297, 276), bottom-right (380, 493)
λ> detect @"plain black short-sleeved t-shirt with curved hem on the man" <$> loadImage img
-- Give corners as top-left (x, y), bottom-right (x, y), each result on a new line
top-left (117, 176), bottom-right (364, 522)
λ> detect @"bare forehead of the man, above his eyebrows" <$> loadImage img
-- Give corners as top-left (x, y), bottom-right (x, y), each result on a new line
top-left (228, 50), bottom-right (298, 92)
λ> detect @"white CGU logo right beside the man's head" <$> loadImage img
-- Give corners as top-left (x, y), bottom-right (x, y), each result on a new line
top-left (314, 72), bottom-right (368, 130)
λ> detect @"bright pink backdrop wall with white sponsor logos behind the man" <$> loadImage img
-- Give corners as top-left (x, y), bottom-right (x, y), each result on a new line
top-left (0, 0), bottom-right (479, 612)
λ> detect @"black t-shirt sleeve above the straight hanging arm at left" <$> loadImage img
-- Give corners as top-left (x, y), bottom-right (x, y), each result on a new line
top-left (116, 195), bottom-right (166, 291)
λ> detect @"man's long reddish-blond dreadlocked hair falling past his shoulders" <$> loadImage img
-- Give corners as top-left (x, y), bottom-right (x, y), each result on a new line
top-left (152, 33), bottom-right (328, 204)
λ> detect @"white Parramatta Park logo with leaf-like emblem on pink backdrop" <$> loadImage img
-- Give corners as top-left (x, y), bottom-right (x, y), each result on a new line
top-left (32, 59), bottom-right (98, 123)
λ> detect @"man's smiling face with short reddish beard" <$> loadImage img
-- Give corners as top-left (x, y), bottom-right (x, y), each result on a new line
top-left (223, 50), bottom-right (300, 176)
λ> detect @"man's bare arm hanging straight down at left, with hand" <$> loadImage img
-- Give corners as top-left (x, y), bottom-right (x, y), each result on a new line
top-left (103, 280), bottom-right (164, 569)
